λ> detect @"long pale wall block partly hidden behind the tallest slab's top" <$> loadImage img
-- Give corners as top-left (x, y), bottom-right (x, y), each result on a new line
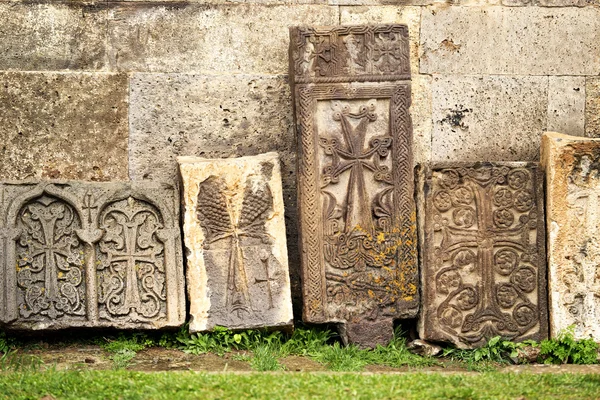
top-left (108, 3), bottom-right (339, 74)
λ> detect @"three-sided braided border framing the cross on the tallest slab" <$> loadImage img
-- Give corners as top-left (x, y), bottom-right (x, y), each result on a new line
top-left (295, 82), bottom-right (419, 322)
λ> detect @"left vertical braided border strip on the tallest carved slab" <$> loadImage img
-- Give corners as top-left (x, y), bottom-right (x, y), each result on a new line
top-left (297, 87), bottom-right (325, 321)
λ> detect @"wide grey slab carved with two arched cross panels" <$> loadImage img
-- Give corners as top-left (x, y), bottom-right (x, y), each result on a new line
top-left (0, 181), bottom-right (185, 329)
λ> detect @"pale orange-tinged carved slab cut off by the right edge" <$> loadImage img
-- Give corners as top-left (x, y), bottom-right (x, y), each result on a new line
top-left (542, 133), bottom-right (600, 342)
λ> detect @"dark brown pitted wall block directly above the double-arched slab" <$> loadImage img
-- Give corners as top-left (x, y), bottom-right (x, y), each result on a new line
top-left (0, 72), bottom-right (127, 180)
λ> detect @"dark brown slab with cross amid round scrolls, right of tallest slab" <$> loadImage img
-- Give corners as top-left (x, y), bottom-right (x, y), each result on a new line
top-left (419, 162), bottom-right (547, 348)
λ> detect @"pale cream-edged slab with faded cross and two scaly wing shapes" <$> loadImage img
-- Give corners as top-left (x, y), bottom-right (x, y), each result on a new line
top-left (177, 153), bottom-right (293, 332)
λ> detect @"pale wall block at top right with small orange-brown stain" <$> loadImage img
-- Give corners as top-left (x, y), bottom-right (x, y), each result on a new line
top-left (420, 6), bottom-right (600, 75)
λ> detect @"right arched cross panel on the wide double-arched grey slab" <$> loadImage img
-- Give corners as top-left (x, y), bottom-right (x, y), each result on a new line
top-left (97, 197), bottom-right (166, 321)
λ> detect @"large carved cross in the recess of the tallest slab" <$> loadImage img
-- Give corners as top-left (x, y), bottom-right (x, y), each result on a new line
top-left (319, 103), bottom-right (392, 235)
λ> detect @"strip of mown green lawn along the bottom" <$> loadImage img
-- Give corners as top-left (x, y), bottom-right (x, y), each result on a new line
top-left (0, 370), bottom-right (600, 399)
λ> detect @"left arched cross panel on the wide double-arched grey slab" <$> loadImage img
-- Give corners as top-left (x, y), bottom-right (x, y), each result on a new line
top-left (17, 194), bottom-right (86, 319)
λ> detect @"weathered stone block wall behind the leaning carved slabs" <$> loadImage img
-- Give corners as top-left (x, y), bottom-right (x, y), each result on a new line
top-left (0, 0), bottom-right (600, 315)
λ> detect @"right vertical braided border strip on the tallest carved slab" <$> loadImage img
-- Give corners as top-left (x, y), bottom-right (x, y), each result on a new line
top-left (390, 84), bottom-right (419, 307)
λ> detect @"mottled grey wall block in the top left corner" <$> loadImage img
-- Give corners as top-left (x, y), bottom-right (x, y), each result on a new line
top-left (0, 2), bottom-right (107, 71)
